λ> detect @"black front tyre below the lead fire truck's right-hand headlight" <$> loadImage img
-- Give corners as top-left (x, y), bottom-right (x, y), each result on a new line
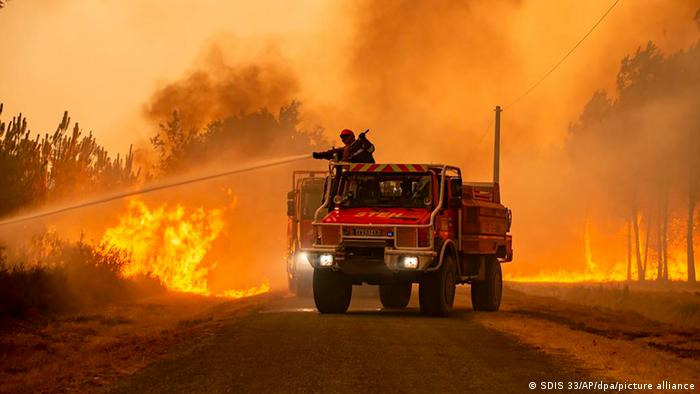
top-left (418, 253), bottom-right (457, 317)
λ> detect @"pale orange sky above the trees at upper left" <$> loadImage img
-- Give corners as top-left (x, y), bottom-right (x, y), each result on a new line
top-left (0, 0), bottom-right (325, 151)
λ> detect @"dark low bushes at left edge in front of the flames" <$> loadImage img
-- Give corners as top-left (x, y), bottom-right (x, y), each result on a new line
top-left (0, 233), bottom-right (162, 318)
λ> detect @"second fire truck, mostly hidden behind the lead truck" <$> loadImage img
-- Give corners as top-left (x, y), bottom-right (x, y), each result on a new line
top-left (287, 170), bottom-right (328, 296)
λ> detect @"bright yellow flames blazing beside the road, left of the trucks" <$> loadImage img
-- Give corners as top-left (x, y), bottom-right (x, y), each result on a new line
top-left (101, 199), bottom-right (270, 298)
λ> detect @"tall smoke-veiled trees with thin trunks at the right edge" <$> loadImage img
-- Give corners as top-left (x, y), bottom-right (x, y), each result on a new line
top-left (568, 42), bottom-right (700, 282)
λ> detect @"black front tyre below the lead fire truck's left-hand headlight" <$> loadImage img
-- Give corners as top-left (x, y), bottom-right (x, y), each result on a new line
top-left (313, 269), bottom-right (352, 313)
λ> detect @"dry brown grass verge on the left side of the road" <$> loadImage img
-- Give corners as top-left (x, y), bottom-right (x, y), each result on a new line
top-left (0, 294), bottom-right (268, 392)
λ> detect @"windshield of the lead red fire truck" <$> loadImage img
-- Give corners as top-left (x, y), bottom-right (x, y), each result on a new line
top-left (338, 173), bottom-right (433, 208)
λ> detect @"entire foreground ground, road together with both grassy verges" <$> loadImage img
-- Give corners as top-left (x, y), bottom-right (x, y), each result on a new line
top-left (0, 284), bottom-right (700, 392)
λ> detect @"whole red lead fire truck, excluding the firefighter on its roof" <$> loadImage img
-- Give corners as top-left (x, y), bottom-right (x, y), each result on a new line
top-left (305, 163), bottom-right (513, 316)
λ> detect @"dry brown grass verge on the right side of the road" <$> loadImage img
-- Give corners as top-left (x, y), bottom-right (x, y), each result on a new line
top-left (477, 284), bottom-right (700, 387)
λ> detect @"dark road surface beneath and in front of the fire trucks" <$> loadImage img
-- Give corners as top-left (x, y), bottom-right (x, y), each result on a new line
top-left (108, 289), bottom-right (595, 393)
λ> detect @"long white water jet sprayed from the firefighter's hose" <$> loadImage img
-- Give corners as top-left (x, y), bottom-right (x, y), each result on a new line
top-left (0, 154), bottom-right (310, 227)
